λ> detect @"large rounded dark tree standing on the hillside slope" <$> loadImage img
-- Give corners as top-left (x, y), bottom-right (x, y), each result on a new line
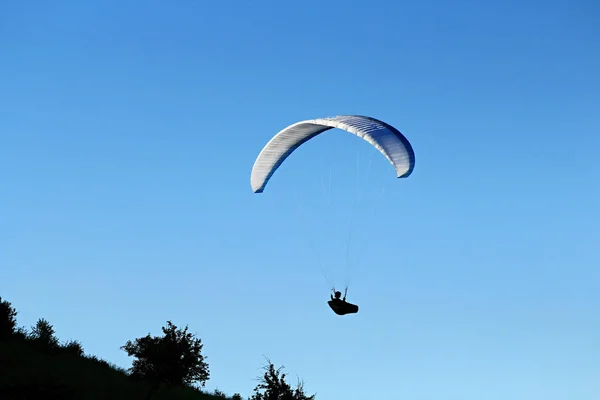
top-left (121, 321), bottom-right (210, 387)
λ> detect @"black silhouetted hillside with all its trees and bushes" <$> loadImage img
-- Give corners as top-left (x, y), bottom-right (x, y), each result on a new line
top-left (0, 297), bottom-right (315, 400)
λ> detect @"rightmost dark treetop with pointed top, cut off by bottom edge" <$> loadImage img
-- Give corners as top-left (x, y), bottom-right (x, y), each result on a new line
top-left (250, 360), bottom-right (315, 400)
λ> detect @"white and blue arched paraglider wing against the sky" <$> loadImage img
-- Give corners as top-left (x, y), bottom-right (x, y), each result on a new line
top-left (250, 115), bottom-right (415, 193)
